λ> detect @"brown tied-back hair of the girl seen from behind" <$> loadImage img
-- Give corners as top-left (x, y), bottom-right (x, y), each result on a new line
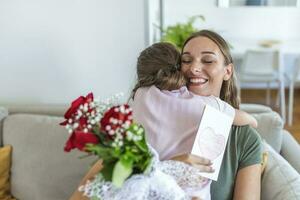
top-left (131, 42), bottom-right (186, 98)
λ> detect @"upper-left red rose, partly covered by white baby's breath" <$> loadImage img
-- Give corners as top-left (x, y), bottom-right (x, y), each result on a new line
top-left (60, 93), bottom-right (94, 126)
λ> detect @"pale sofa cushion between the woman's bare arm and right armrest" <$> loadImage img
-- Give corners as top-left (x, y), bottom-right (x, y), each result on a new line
top-left (261, 143), bottom-right (300, 200)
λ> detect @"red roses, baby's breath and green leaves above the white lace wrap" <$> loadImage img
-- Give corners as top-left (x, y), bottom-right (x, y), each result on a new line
top-left (61, 93), bottom-right (152, 187)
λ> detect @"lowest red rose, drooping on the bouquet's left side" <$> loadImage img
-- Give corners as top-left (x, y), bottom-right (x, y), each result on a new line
top-left (64, 132), bottom-right (99, 152)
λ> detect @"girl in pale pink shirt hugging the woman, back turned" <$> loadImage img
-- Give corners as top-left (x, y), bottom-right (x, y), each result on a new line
top-left (132, 43), bottom-right (257, 199)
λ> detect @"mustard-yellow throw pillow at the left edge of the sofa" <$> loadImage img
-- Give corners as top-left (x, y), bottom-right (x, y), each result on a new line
top-left (0, 145), bottom-right (14, 200)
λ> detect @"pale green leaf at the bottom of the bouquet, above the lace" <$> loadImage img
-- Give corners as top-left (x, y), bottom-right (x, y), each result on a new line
top-left (112, 159), bottom-right (132, 187)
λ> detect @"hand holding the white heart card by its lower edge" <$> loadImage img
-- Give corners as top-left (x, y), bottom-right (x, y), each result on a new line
top-left (171, 154), bottom-right (215, 173)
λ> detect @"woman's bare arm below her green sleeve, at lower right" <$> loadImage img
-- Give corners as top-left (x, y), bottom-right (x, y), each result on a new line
top-left (233, 164), bottom-right (261, 200)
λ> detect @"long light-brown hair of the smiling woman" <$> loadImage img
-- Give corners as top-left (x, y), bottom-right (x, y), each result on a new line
top-left (182, 30), bottom-right (240, 109)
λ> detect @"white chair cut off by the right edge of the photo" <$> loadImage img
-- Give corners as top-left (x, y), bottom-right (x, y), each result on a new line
top-left (285, 57), bottom-right (300, 126)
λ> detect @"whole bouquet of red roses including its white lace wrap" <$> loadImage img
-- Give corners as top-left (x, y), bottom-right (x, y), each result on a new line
top-left (60, 93), bottom-right (209, 200)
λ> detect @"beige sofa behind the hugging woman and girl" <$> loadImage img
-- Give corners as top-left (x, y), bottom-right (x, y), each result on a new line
top-left (0, 105), bottom-right (300, 200)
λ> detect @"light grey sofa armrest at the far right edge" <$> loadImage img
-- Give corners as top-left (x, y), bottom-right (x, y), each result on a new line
top-left (280, 130), bottom-right (300, 173)
